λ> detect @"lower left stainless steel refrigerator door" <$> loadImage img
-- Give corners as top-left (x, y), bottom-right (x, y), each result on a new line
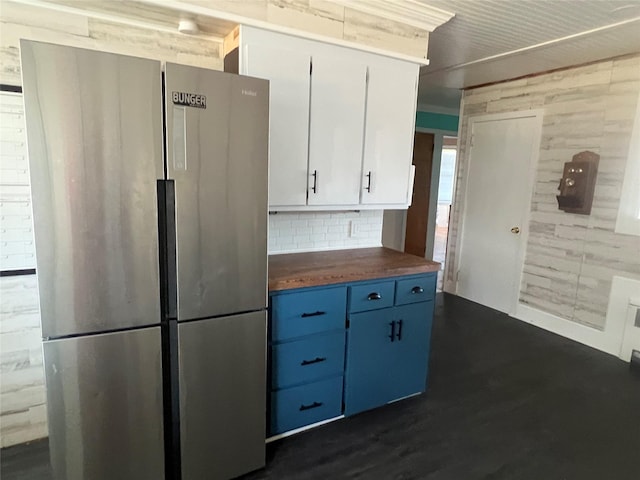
top-left (44, 327), bottom-right (164, 480)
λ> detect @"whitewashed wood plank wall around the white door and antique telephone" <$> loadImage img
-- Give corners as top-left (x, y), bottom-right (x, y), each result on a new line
top-left (445, 55), bottom-right (640, 330)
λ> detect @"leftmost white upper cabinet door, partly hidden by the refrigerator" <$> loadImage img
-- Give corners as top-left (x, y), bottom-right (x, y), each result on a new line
top-left (244, 44), bottom-right (311, 207)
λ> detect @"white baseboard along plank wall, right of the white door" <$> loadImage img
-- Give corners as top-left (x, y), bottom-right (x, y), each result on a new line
top-left (512, 303), bottom-right (622, 357)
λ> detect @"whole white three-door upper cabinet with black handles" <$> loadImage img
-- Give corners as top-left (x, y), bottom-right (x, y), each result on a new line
top-left (225, 26), bottom-right (419, 211)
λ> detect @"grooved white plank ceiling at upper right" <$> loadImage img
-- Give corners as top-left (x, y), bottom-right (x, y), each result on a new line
top-left (418, 0), bottom-right (640, 97)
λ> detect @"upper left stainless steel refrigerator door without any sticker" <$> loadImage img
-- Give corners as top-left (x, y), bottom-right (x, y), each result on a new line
top-left (21, 40), bottom-right (164, 337)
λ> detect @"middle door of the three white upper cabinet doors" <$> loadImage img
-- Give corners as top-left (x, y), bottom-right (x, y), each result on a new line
top-left (308, 52), bottom-right (367, 205)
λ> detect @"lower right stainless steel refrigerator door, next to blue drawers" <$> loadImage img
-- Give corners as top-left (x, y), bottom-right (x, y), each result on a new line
top-left (178, 311), bottom-right (267, 480)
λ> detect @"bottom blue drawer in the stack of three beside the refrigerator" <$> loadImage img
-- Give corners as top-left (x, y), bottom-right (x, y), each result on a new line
top-left (270, 377), bottom-right (342, 435)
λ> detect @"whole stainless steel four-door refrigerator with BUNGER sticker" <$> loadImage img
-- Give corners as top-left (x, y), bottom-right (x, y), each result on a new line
top-left (21, 41), bottom-right (269, 480)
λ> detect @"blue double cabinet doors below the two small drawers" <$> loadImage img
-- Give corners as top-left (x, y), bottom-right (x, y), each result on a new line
top-left (345, 302), bottom-right (433, 415)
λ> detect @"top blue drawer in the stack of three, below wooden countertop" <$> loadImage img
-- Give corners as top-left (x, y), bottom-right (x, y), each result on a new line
top-left (271, 287), bottom-right (347, 342)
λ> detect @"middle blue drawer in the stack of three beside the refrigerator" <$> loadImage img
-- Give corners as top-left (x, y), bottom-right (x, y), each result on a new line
top-left (271, 331), bottom-right (345, 389)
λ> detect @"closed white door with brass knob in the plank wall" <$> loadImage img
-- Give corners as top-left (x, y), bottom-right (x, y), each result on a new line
top-left (457, 112), bottom-right (542, 313)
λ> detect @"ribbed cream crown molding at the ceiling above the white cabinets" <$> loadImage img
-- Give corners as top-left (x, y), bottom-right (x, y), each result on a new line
top-left (330, 0), bottom-right (455, 32)
